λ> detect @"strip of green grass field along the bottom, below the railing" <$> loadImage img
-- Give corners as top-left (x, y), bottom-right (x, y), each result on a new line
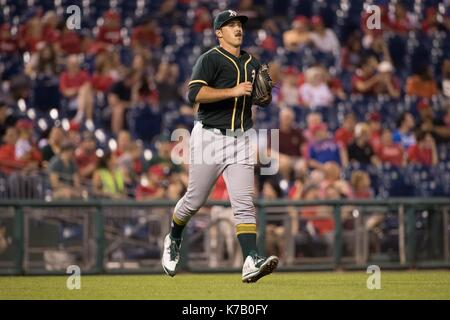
top-left (0, 271), bottom-right (450, 300)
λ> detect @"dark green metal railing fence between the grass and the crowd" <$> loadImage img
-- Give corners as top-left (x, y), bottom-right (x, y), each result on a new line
top-left (0, 198), bottom-right (450, 274)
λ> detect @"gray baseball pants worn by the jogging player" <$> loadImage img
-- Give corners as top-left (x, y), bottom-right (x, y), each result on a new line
top-left (173, 122), bottom-right (256, 230)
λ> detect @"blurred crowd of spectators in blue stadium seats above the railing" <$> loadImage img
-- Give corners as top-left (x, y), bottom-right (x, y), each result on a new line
top-left (0, 0), bottom-right (450, 206)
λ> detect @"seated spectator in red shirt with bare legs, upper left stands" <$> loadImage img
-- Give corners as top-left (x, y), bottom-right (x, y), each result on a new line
top-left (59, 55), bottom-right (94, 122)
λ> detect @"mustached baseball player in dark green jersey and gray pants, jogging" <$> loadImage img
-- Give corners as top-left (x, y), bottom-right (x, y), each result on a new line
top-left (162, 10), bottom-right (278, 282)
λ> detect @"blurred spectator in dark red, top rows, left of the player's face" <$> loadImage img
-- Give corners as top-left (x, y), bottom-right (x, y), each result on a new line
top-left (131, 18), bottom-right (162, 51)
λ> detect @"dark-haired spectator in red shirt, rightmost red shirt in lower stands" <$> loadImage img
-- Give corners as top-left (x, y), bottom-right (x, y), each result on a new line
top-left (408, 130), bottom-right (438, 166)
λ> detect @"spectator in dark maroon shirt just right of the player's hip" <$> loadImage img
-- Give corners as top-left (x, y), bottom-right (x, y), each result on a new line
top-left (279, 108), bottom-right (306, 179)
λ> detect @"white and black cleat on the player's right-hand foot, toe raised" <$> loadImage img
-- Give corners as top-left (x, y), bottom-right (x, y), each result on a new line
top-left (242, 251), bottom-right (279, 283)
